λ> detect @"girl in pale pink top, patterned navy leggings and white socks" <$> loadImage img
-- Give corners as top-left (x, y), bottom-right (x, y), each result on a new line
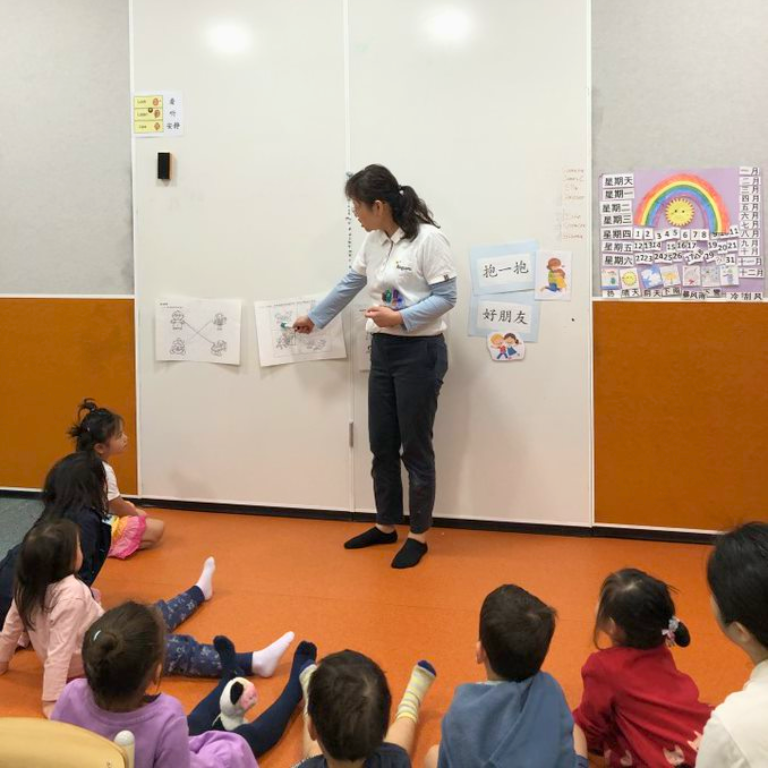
top-left (0, 520), bottom-right (293, 716)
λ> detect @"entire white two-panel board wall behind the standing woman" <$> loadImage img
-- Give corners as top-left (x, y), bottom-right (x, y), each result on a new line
top-left (134, 0), bottom-right (591, 524)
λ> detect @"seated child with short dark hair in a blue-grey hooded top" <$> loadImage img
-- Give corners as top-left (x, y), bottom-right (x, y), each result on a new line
top-left (425, 584), bottom-right (587, 768)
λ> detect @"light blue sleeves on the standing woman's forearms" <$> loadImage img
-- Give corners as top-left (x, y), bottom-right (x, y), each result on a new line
top-left (309, 270), bottom-right (456, 333)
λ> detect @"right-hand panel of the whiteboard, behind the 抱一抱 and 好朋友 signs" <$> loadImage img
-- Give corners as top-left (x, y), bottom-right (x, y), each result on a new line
top-left (350, 0), bottom-right (591, 524)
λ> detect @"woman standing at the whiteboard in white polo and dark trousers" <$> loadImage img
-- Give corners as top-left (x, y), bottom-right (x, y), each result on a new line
top-left (293, 165), bottom-right (456, 568)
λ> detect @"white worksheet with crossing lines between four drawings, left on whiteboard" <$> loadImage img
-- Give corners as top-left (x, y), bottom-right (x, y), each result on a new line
top-left (155, 297), bottom-right (242, 365)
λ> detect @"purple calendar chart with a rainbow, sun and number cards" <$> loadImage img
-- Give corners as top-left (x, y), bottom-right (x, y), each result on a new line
top-left (599, 166), bottom-right (765, 301)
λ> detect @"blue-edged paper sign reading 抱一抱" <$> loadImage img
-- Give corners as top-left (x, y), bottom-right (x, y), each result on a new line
top-left (469, 240), bottom-right (538, 296)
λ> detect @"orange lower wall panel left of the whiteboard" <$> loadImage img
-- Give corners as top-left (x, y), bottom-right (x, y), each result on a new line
top-left (0, 297), bottom-right (137, 494)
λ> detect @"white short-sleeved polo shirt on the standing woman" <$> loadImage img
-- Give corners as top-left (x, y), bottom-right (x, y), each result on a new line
top-left (352, 224), bottom-right (456, 336)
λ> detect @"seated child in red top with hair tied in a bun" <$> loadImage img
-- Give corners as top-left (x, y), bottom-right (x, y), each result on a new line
top-left (573, 568), bottom-right (712, 768)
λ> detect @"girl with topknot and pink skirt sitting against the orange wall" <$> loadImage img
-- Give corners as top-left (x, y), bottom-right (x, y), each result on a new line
top-left (68, 398), bottom-right (165, 560)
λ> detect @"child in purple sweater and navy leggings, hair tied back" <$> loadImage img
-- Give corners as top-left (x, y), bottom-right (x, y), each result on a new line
top-left (53, 602), bottom-right (317, 768)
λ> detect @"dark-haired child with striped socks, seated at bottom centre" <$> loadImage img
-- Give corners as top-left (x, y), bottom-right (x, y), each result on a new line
top-left (300, 651), bottom-right (436, 768)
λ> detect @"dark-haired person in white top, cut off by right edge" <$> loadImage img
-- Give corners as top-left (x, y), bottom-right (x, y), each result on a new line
top-left (696, 523), bottom-right (768, 768)
